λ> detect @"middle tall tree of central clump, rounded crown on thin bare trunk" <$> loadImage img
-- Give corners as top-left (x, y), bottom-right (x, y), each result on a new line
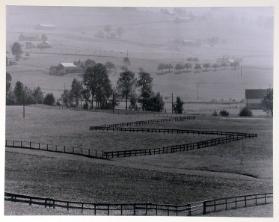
top-left (117, 71), bottom-right (136, 110)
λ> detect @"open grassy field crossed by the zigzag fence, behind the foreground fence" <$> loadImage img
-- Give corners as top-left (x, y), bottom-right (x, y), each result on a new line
top-left (5, 106), bottom-right (272, 214)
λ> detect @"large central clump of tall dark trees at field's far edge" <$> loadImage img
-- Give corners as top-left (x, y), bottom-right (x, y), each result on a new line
top-left (61, 63), bottom-right (164, 111)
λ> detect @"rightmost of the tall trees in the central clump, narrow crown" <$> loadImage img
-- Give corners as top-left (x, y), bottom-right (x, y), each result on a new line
top-left (137, 72), bottom-right (153, 110)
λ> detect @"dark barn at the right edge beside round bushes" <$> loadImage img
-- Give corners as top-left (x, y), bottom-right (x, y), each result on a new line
top-left (245, 89), bottom-right (267, 109)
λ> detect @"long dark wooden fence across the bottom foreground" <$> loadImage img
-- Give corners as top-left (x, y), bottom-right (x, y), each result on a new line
top-left (5, 192), bottom-right (273, 216)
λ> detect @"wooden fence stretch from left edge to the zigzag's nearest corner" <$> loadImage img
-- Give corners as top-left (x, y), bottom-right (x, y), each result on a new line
top-left (5, 140), bottom-right (108, 159)
